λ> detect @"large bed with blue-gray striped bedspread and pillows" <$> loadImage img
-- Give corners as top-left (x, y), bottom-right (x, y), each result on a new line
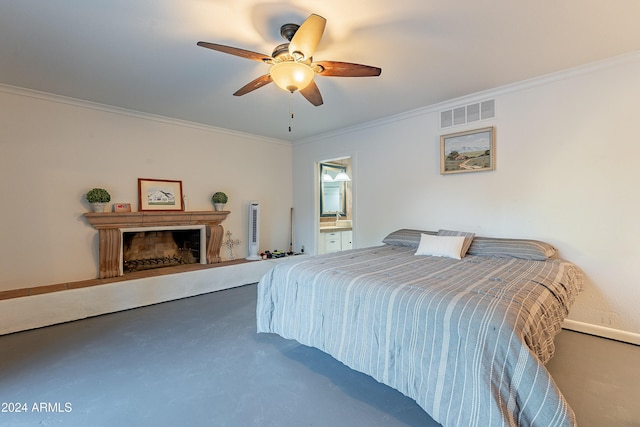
top-left (256, 229), bottom-right (582, 427)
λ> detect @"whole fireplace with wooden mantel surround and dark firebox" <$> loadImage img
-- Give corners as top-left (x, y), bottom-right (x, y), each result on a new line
top-left (84, 211), bottom-right (229, 279)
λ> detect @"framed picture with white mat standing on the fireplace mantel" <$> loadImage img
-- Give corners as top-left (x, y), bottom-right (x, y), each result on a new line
top-left (138, 178), bottom-right (184, 211)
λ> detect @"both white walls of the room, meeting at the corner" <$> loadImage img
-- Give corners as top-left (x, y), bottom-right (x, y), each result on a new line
top-left (5, 54), bottom-right (640, 342)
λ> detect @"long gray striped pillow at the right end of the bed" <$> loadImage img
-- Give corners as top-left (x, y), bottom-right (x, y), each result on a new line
top-left (467, 237), bottom-right (556, 261)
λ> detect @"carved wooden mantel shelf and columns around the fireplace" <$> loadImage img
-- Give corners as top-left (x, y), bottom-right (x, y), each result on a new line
top-left (84, 211), bottom-right (229, 279)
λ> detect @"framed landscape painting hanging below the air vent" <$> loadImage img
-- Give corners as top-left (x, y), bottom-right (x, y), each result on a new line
top-left (440, 126), bottom-right (496, 175)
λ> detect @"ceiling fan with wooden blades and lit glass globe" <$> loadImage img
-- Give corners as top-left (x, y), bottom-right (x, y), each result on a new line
top-left (198, 14), bottom-right (382, 106)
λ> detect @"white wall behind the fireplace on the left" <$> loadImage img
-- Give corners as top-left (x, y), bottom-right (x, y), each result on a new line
top-left (0, 86), bottom-right (292, 291)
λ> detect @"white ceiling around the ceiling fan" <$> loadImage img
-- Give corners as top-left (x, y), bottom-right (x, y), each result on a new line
top-left (0, 0), bottom-right (640, 141)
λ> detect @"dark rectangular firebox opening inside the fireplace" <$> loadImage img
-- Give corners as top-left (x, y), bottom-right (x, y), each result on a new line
top-left (121, 227), bottom-right (206, 274)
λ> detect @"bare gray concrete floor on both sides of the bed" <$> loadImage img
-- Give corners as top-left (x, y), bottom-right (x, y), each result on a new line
top-left (0, 285), bottom-right (640, 427)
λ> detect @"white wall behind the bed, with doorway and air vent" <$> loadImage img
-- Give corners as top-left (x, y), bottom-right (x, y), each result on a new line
top-left (293, 53), bottom-right (640, 340)
